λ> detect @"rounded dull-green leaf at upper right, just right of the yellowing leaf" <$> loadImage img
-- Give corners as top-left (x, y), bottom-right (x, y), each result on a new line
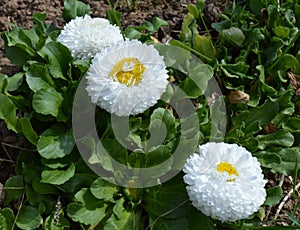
top-left (221, 27), bottom-right (246, 47)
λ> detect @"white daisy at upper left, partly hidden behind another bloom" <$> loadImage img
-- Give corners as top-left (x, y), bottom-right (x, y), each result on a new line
top-left (57, 15), bottom-right (123, 60)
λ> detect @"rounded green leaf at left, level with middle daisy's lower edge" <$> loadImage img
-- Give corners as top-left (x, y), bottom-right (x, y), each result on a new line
top-left (32, 88), bottom-right (63, 117)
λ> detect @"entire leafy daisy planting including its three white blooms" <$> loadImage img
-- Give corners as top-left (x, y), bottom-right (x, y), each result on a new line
top-left (0, 0), bottom-right (300, 229)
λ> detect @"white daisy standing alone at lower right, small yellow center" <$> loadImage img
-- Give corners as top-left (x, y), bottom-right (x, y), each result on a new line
top-left (183, 142), bottom-right (267, 221)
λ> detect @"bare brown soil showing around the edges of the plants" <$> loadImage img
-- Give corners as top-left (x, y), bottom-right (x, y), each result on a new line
top-left (0, 0), bottom-right (300, 226)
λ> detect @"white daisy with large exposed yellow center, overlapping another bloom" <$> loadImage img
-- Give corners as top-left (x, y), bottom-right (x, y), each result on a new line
top-left (86, 40), bottom-right (169, 117)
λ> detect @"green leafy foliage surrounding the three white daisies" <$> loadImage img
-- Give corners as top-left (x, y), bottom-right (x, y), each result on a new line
top-left (0, 0), bottom-right (300, 230)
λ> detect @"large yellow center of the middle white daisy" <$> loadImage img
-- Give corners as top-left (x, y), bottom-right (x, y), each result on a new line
top-left (109, 57), bottom-right (146, 87)
